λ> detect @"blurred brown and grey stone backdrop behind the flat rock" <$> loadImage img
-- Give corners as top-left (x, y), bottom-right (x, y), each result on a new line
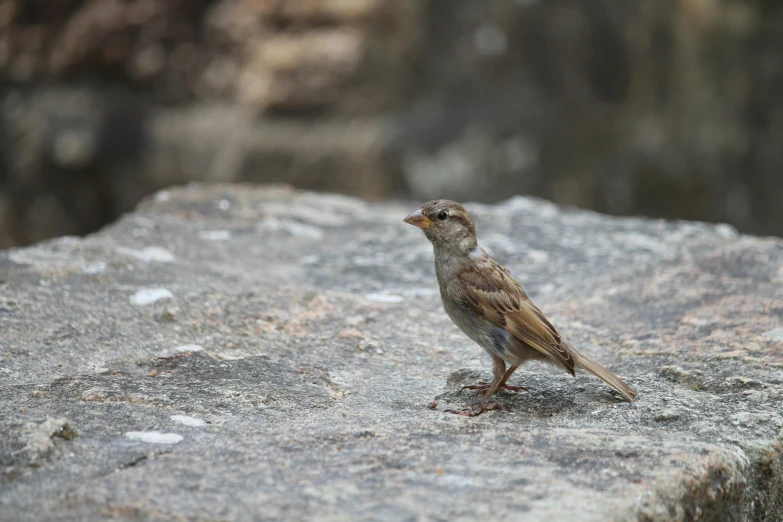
top-left (0, 0), bottom-right (783, 248)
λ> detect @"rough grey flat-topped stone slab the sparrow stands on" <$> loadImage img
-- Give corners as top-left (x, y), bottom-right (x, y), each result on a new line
top-left (0, 185), bottom-right (783, 522)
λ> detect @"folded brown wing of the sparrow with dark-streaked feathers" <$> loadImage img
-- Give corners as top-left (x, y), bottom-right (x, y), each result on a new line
top-left (449, 256), bottom-right (574, 375)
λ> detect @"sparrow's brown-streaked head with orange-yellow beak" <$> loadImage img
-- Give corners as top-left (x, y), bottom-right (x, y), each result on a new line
top-left (404, 199), bottom-right (476, 254)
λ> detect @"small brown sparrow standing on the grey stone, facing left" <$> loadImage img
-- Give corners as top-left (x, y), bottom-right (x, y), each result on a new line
top-left (404, 199), bottom-right (636, 416)
